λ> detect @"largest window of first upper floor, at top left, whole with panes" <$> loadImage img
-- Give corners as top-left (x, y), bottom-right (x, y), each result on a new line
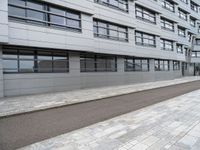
top-left (8, 0), bottom-right (81, 31)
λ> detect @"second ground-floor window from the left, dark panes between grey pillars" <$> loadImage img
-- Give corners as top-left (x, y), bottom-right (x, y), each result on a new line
top-left (80, 53), bottom-right (117, 72)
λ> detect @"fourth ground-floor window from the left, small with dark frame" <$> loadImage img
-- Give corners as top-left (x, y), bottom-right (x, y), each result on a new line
top-left (155, 59), bottom-right (170, 71)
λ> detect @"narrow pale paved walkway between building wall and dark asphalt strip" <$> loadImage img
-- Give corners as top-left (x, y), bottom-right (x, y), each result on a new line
top-left (0, 77), bottom-right (200, 117)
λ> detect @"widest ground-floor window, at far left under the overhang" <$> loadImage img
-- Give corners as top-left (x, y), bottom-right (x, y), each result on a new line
top-left (3, 47), bottom-right (69, 73)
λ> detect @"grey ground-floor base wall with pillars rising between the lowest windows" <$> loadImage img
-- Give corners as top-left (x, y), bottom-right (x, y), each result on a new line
top-left (3, 53), bottom-right (182, 96)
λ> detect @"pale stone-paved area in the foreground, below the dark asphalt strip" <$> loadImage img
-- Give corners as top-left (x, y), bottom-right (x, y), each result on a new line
top-left (19, 90), bottom-right (200, 150)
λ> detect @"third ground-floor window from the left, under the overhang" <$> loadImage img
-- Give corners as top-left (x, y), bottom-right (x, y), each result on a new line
top-left (124, 57), bottom-right (149, 71)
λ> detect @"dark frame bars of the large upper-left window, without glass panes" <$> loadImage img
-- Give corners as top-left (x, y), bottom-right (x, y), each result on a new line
top-left (8, 0), bottom-right (82, 32)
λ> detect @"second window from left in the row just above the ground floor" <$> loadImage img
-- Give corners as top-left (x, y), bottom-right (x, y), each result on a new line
top-left (93, 20), bottom-right (128, 41)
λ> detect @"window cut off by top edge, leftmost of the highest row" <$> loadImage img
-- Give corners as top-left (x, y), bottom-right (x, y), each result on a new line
top-left (94, 0), bottom-right (128, 12)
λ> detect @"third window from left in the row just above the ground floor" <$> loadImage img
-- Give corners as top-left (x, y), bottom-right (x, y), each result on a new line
top-left (135, 31), bottom-right (156, 47)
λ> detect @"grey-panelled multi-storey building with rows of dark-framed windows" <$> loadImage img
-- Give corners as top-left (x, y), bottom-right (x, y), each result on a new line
top-left (0, 0), bottom-right (200, 97)
